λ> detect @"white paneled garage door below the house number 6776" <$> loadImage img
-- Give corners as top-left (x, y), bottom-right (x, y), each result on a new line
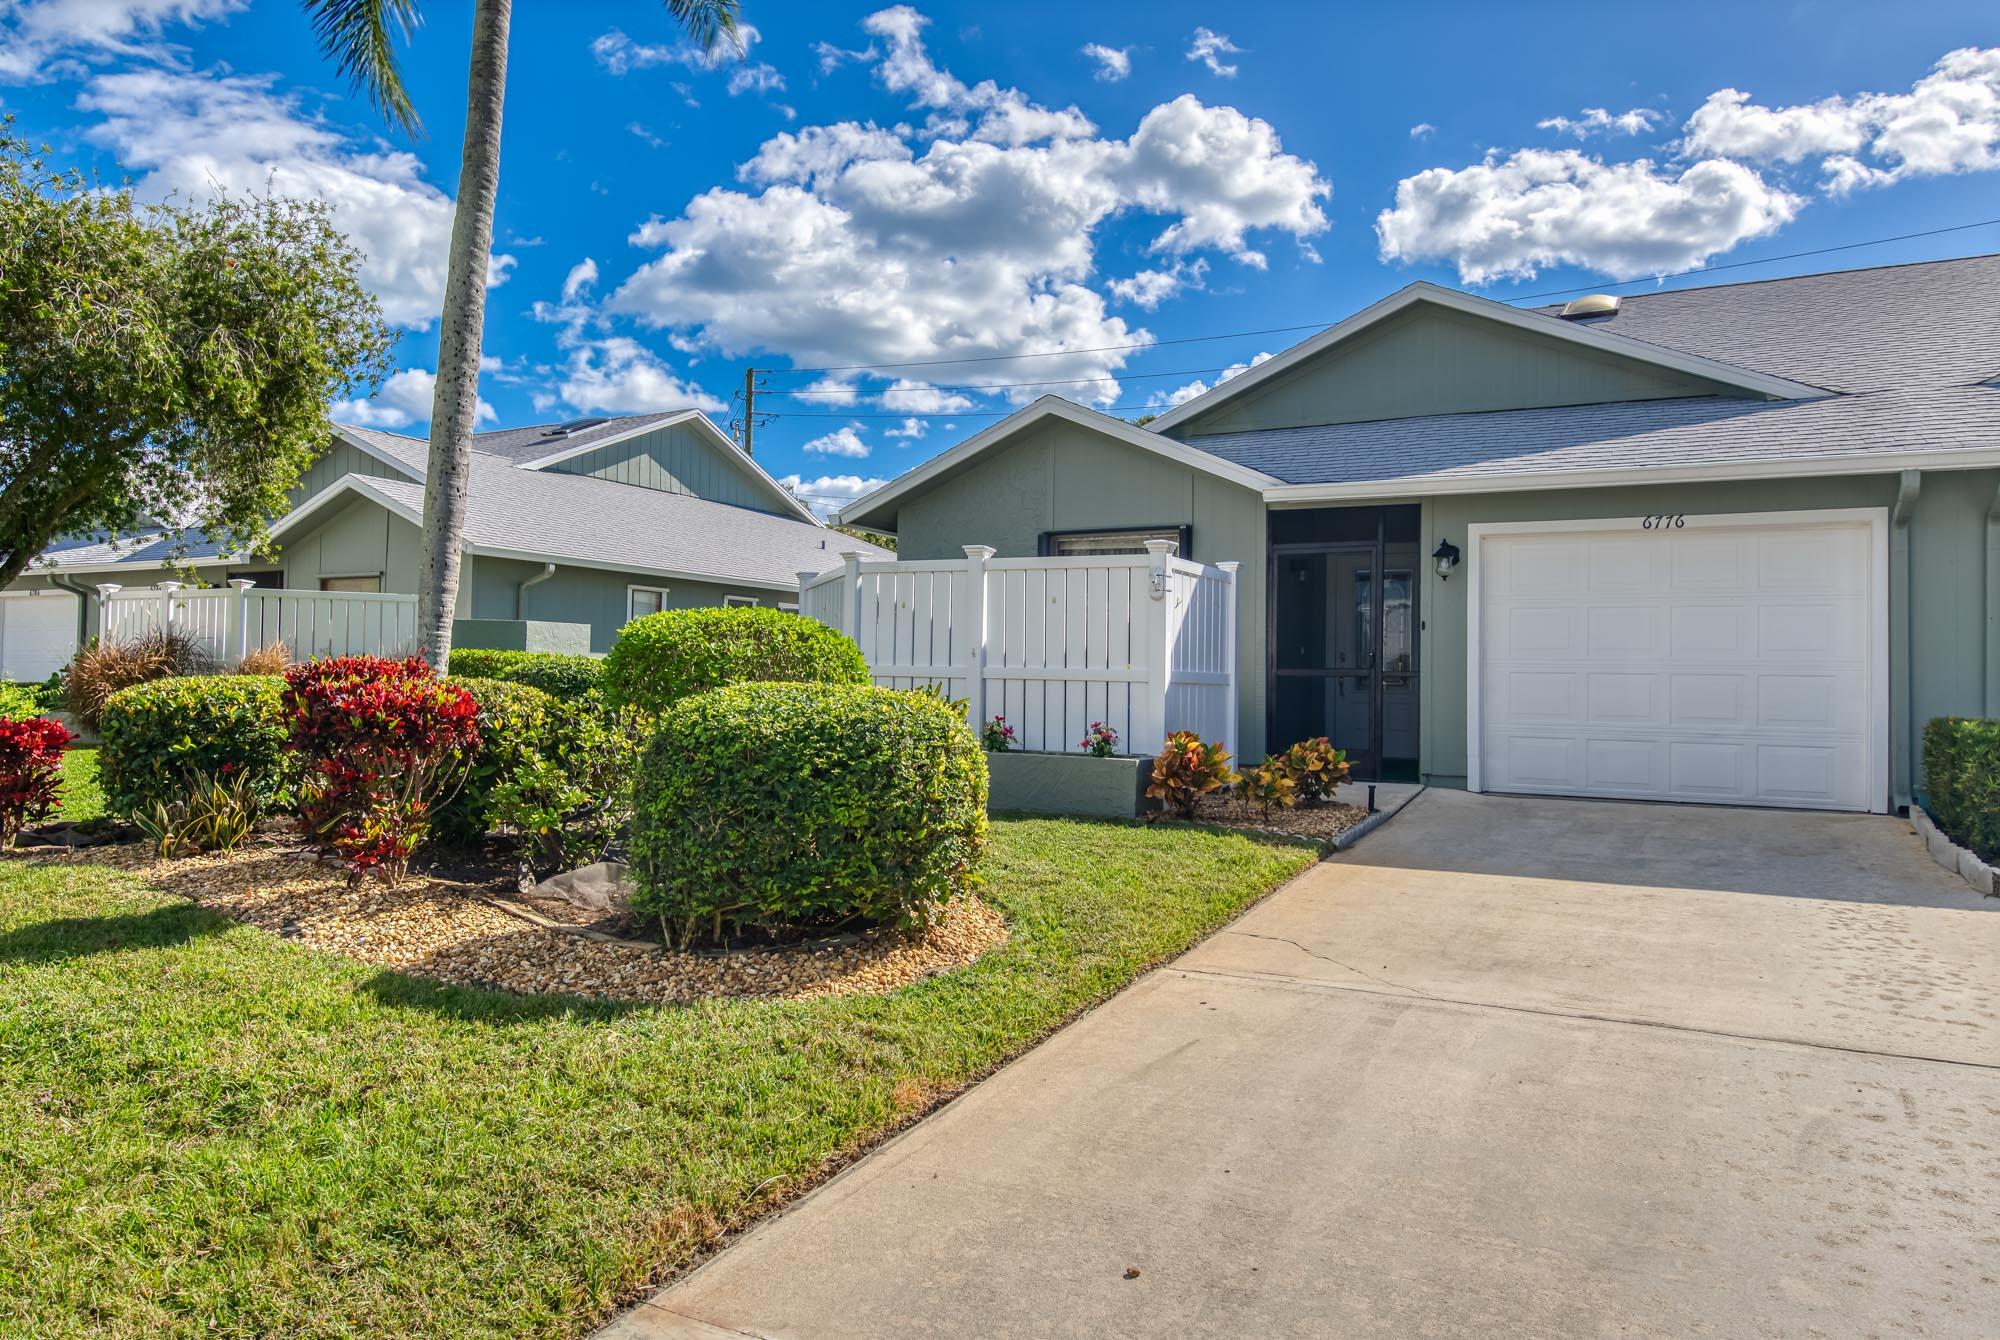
top-left (1468, 512), bottom-right (1888, 810)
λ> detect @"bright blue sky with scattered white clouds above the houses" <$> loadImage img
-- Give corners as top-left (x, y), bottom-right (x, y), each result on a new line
top-left (0, 0), bottom-right (2000, 516)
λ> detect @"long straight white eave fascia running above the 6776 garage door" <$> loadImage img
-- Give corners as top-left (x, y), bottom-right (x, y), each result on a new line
top-left (1264, 448), bottom-right (2000, 504)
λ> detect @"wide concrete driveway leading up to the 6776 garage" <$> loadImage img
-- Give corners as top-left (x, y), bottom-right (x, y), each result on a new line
top-left (606, 792), bottom-right (2000, 1340)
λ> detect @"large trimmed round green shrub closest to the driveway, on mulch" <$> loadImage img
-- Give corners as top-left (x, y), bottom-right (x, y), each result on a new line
top-left (632, 684), bottom-right (986, 946)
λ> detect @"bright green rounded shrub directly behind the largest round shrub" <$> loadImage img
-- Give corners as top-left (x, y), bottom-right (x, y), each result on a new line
top-left (604, 606), bottom-right (868, 712)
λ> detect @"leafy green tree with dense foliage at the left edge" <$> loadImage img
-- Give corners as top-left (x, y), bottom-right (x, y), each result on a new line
top-left (0, 120), bottom-right (390, 586)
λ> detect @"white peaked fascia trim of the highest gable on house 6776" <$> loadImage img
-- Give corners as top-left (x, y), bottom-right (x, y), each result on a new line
top-left (1146, 282), bottom-right (1832, 432)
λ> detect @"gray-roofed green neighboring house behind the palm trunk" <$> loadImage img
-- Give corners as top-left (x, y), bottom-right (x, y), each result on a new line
top-left (0, 410), bottom-right (886, 680)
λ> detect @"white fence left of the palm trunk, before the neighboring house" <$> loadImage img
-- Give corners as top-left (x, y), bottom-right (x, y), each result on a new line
top-left (98, 578), bottom-right (418, 662)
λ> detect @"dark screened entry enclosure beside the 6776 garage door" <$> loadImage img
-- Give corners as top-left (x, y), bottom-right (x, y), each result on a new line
top-left (1266, 506), bottom-right (1424, 782)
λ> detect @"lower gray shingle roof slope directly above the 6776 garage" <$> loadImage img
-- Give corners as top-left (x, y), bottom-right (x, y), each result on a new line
top-left (1186, 386), bottom-right (2000, 488)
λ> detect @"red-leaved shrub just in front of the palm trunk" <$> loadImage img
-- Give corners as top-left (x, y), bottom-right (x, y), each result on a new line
top-left (284, 656), bottom-right (480, 884)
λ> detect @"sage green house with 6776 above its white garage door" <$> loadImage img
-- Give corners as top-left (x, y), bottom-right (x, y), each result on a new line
top-left (840, 256), bottom-right (2000, 810)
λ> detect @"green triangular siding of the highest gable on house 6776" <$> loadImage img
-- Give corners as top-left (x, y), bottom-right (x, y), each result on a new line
top-left (1170, 304), bottom-right (1744, 438)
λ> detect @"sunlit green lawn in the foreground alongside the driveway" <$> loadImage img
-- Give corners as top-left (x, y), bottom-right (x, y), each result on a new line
top-left (0, 820), bottom-right (1314, 1338)
